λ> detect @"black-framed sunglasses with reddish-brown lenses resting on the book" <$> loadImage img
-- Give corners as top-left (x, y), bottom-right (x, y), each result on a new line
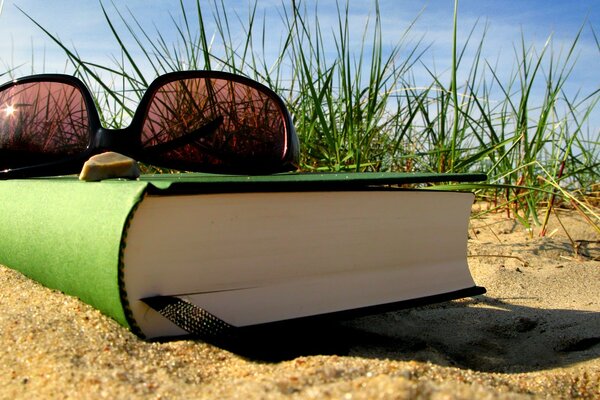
top-left (0, 71), bottom-right (299, 179)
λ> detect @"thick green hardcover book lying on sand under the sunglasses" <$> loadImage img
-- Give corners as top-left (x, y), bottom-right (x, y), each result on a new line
top-left (0, 173), bottom-right (485, 339)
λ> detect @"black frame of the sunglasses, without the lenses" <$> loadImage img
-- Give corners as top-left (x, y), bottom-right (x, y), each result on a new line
top-left (0, 70), bottom-right (300, 180)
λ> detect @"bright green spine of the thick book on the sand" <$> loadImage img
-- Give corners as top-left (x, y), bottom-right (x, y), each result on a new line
top-left (0, 178), bottom-right (147, 327)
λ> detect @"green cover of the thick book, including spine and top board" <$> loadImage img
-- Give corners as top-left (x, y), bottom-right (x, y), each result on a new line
top-left (0, 173), bottom-right (485, 338)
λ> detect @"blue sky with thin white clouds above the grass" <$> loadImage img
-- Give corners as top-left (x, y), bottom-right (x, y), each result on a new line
top-left (0, 0), bottom-right (600, 133)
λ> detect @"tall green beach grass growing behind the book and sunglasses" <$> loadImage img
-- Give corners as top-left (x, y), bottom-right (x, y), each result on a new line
top-left (12, 0), bottom-right (600, 233)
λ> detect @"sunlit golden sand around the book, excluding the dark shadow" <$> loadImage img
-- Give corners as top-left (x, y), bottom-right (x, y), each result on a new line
top-left (0, 210), bottom-right (600, 399)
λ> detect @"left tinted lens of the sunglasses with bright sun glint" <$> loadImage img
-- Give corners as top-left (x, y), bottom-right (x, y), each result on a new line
top-left (0, 82), bottom-right (89, 170)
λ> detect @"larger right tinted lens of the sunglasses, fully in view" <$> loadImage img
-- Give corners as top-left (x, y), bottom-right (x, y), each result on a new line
top-left (142, 78), bottom-right (287, 170)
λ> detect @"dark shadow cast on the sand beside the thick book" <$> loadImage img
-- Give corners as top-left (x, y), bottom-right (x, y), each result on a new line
top-left (199, 296), bottom-right (600, 372)
